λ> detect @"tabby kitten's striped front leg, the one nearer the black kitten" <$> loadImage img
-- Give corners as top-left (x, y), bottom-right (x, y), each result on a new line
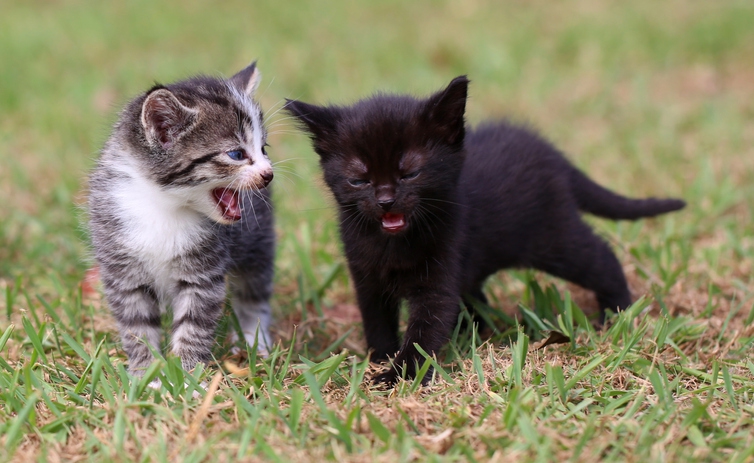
top-left (171, 273), bottom-right (225, 371)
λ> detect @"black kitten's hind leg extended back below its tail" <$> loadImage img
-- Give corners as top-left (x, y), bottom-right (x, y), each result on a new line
top-left (534, 221), bottom-right (631, 322)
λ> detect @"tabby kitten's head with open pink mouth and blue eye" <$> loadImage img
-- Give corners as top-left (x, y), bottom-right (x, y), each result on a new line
top-left (122, 63), bottom-right (273, 224)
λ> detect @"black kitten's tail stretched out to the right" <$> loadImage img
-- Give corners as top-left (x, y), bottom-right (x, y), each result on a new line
top-left (571, 168), bottom-right (686, 220)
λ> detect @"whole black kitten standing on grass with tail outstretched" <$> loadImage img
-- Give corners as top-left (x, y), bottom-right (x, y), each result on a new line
top-left (286, 76), bottom-right (685, 384)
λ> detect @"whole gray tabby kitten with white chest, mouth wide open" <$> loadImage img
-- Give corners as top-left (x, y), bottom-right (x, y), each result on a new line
top-left (89, 63), bottom-right (275, 375)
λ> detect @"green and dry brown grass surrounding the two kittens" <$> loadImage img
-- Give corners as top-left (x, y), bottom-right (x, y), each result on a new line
top-left (0, 0), bottom-right (754, 462)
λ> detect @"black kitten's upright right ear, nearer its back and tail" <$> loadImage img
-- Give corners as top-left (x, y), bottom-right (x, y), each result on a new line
top-left (425, 76), bottom-right (469, 145)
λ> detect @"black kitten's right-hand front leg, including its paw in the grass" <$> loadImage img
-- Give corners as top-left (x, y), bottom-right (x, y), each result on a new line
top-left (374, 284), bottom-right (461, 385)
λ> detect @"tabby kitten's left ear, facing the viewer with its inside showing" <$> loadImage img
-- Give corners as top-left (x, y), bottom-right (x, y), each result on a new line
top-left (141, 87), bottom-right (199, 150)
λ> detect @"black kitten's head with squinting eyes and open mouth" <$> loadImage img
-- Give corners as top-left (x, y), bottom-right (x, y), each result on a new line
top-left (286, 76), bottom-right (469, 233)
